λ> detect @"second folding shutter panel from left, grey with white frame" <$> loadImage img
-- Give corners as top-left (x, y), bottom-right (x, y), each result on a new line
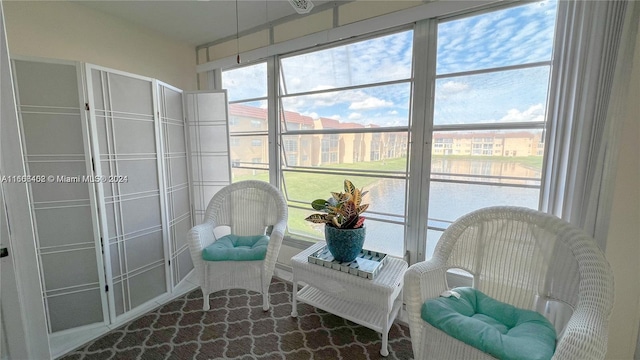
top-left (87, 65), bottom-right (168, 317)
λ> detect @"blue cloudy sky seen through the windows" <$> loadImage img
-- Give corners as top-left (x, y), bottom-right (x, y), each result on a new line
top-left (223, 1), bottom-right (556, 126)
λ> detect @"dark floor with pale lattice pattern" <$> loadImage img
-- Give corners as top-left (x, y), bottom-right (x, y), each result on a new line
top-left (60, 279), bottom-right (413, 360)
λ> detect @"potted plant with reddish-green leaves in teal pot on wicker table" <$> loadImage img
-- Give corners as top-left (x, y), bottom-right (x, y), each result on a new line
top-left (305, 180), bottom-right (369, 262)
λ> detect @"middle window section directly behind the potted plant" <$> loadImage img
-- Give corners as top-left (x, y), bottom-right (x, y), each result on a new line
top-left (278, 30), bottom-right (413, 256)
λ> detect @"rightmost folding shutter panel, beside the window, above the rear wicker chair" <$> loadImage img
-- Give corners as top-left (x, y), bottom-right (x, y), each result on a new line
top-left (184, 90), bottom-right (231, 223)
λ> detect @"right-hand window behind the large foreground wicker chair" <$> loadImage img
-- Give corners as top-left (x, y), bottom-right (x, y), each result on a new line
top-left (425, 1), bottom-right (556, 258)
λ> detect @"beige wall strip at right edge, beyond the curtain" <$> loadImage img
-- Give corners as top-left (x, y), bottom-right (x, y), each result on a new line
top-left (606, 25), bottom-right (640, 359)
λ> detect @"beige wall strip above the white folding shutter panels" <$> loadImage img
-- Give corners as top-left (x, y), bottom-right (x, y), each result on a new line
top-left (4, 1), bottom-right (196, 90)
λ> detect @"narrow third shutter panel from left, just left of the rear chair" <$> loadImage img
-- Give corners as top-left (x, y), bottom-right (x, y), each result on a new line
top-left (158, 82), bottom-right (193, 286)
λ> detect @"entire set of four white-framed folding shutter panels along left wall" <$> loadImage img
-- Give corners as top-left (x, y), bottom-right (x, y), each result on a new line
top-left (12, 59), bottom-right (230, 338)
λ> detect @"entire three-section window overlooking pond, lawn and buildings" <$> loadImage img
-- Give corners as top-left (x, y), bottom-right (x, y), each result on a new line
top-left (222, 0), bottom-right (557, 258)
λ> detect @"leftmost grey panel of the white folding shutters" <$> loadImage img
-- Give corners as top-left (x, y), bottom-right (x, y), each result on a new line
top-left (13, 60), bottom-right (107, 333)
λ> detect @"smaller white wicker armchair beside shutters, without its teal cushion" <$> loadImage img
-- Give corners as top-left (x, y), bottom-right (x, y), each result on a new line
top-left (188, 180), bottom-right (287, 311)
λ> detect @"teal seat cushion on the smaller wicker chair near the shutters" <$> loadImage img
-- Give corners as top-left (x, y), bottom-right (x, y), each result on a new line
top-left (202, 234), bottom-right (269, 261)
